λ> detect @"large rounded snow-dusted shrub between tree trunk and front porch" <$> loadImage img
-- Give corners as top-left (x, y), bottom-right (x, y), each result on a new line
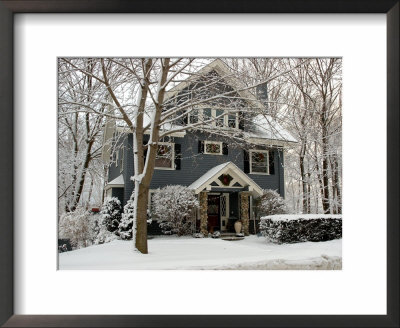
top-left (152, 185), bottom-right (199, 236)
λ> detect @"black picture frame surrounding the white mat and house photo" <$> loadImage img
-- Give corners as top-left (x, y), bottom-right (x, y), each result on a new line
top-left (0, 0), bottom-right (400, 327)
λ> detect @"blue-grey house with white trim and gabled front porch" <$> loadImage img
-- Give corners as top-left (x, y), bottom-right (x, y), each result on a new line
top-left (103, 60), bottom-right (296, 235)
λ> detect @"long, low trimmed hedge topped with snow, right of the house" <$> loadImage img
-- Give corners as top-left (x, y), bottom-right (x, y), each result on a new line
top-left (260, 214), bottom-right (342, 244)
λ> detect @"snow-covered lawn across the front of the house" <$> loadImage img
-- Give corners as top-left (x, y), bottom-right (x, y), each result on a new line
top-left (59, 236), bottom-right (342, 270)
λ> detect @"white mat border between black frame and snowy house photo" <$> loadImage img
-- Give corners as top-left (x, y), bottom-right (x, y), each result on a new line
top-left (15, 14), bottom-right (386, 314)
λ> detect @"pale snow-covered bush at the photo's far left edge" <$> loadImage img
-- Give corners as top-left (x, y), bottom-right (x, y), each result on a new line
top-left (58, 207), bottom-right (96, 248)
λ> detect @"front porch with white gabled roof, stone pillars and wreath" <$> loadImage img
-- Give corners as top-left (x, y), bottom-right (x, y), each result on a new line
top-left (190, 162), bottom-right (262, 236)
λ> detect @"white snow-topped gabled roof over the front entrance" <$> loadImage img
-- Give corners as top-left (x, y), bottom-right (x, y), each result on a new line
top-left (189, 162), bottom-right (263, 196)
